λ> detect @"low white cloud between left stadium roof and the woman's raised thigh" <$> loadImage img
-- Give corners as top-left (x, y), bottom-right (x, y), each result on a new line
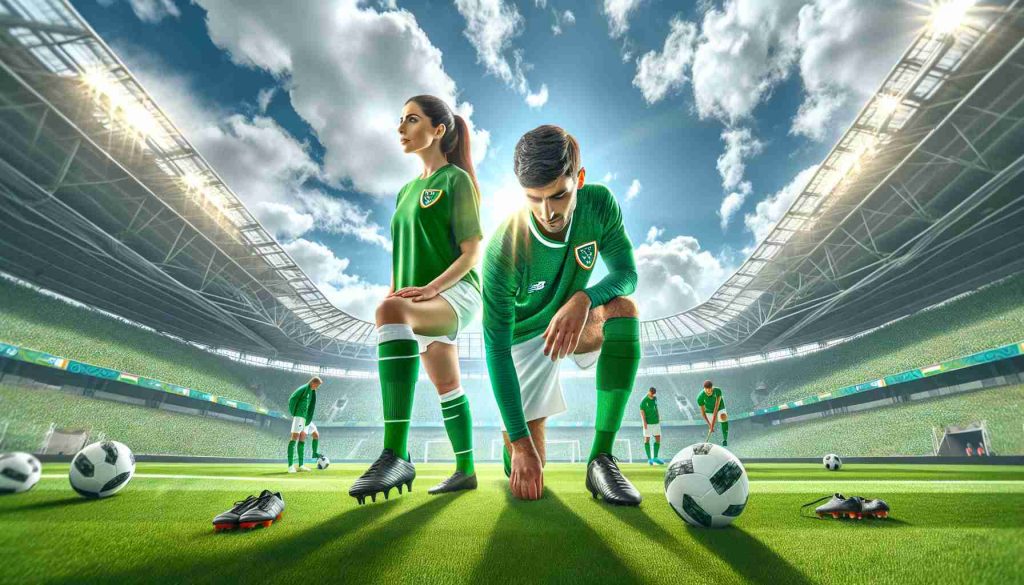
top-left (284, 239), bottom-right (388, 322)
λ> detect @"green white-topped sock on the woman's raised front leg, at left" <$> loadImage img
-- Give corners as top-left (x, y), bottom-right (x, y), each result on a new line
top-left (377, 325), bottom-right (420, 459)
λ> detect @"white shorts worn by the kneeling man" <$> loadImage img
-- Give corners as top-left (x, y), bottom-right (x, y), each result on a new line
top-left (502, 335), bottom-right (601, 430)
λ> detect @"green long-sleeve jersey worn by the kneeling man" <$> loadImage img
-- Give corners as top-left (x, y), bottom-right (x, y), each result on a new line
top-left (483, 184), bottom-right (637, 441)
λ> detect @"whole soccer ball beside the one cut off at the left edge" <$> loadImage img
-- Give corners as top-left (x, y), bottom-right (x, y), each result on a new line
top-left (69, 441), bottom-right (135, 498)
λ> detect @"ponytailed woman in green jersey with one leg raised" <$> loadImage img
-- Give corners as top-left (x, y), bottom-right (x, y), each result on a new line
top-left (348, 95), bottom-right (483, 504)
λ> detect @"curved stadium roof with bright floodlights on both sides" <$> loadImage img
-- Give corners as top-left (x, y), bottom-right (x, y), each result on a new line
top-left (0, 0), bottom-right (1024, 368)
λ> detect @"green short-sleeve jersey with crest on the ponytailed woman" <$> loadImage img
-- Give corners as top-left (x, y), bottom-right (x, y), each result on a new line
top-left (391, 164), bottom-right (483, 290)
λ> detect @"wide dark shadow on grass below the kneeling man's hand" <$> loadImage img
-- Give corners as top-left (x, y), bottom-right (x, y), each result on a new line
top-left (466, 488), bottom-right (640, 583)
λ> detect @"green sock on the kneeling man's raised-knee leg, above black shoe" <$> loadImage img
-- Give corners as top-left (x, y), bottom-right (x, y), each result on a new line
top-left (588, 317), bottom-right (640, 461)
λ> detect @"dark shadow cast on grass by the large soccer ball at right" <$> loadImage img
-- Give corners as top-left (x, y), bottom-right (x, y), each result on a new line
top-left (687, 526), bottom-right (811, 585)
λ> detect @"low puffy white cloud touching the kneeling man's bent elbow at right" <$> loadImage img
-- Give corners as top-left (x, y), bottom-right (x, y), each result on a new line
top-left (634, 232), bottom-right (734, 320)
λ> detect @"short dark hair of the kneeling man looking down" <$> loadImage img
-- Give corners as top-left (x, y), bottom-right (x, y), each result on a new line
top-left (513, 125), bottom-right (580, 187)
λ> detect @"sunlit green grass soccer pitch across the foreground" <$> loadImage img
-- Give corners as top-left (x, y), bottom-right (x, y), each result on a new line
top-left (0, 463), bottom-right (1024, 585)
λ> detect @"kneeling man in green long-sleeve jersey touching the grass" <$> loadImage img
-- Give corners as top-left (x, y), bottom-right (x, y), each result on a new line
top-left (483, 126), bottom-right (641, 505)
